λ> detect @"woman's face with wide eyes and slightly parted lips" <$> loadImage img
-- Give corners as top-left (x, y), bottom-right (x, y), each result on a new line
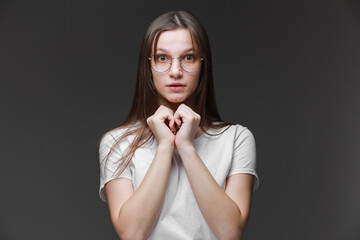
top-left (151, 29), bottom-right (201, 105)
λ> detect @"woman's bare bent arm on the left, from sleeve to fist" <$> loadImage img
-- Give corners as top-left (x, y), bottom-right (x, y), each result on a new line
top-left (105, 106), bottom-right (175, 240)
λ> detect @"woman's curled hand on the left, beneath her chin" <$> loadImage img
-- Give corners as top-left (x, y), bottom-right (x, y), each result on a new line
top-left (147, 105), bottom-right (175, 146)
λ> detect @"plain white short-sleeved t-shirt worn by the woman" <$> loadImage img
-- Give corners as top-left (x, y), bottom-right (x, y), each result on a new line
top-left (99, 125), bottom-right (259, 240)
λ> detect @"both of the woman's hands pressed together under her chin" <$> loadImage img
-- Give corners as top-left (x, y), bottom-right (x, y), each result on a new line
top-left (147, 104), bottom-right (201, 148)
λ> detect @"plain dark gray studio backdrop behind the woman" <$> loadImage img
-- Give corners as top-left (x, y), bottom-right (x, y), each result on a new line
top-left (0, 0), bottom-right (360, 240)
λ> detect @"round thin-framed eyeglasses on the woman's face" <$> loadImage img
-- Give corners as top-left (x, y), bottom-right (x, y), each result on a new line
top-left (149, 54), bottom-right (204, 73)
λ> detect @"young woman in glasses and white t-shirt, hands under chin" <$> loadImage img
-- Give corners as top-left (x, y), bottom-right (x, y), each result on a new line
top-left (99, 11), bottom-right (258, 240)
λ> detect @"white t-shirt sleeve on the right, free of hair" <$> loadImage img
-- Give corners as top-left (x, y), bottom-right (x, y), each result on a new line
top-left (228, 125), bottom-right (259, 191)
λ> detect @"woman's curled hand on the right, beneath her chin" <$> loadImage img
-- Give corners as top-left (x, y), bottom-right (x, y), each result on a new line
top-left (170, 104), bottom-right (201, 150)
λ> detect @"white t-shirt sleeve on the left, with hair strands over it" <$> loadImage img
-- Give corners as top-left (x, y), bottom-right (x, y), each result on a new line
top-left (99, 133), bottom-right (132, 202)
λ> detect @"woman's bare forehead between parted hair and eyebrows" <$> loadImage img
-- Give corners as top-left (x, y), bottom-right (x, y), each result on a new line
top-left (156, 29), bottom-right (194, 53)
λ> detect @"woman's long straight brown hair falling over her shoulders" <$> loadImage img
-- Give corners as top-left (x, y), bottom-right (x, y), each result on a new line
top-left (97, 11), bottom-right (230, 174)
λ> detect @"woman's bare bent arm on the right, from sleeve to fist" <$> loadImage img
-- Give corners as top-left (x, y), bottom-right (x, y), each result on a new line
top-left (174, 105), bottom-right (254, 239)
